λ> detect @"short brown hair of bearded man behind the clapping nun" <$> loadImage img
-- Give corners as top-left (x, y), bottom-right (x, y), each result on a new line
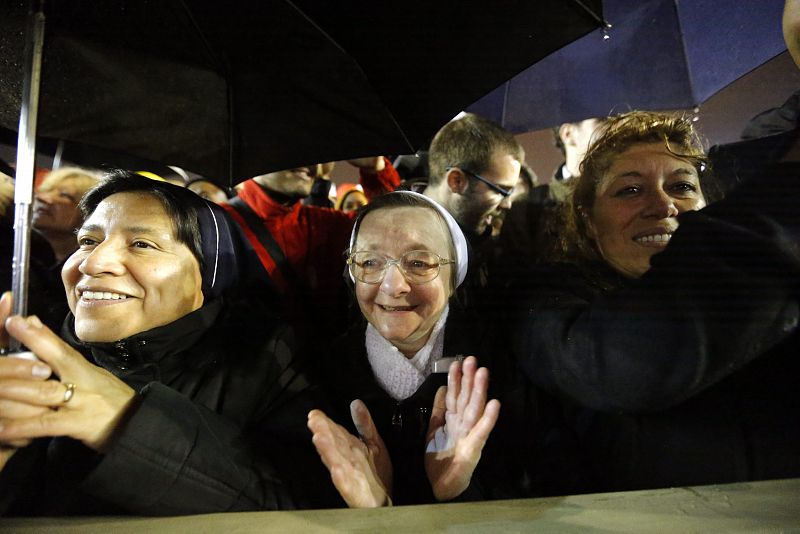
top-left (428, 113), bottom-right (525, 185)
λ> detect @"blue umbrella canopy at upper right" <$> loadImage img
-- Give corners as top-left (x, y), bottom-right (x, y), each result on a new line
top-left (468, 0), bottom-right (786, 133)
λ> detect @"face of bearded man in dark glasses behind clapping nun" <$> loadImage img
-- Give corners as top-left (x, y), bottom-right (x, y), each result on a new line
top-left (453, 152), bottom-right (520, 235)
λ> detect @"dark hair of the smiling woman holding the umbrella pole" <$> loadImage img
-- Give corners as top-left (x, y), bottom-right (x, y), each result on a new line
top-left (78, 169), bottom-right (207, 272)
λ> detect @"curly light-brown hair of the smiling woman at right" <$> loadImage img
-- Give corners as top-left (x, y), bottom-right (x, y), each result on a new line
top-left (553, 111), bottom-right (719, 274)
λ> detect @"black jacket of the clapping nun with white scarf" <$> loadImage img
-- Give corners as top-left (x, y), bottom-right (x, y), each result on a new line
top-left (318, 300), bottom-right (539, 504)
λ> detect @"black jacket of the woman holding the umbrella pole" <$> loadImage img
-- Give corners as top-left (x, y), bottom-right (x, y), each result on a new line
top-left (0, 300), bottom-right (337, 515)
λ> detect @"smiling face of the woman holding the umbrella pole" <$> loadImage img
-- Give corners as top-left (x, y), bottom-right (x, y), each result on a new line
top-left (61, 192), bottom-right (203, 342)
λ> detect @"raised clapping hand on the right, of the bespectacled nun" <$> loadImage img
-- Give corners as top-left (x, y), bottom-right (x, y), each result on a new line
top-left (425, 356), bottom-right (500, 501)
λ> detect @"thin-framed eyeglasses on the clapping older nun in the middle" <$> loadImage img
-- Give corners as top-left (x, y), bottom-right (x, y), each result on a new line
top-left (347, 250), bottom-right (455, 285)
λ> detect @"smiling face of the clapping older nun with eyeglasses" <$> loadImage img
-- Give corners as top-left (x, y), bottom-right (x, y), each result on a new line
top-left (354, 207), bottom-right (452, 357)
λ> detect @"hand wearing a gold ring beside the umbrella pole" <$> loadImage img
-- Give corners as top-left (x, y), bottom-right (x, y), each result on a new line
top-left (0, 304), bottom-right (136, 451)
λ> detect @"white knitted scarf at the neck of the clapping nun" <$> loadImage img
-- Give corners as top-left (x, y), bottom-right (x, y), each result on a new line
top-left (364, 305), bottom-right (450, 400)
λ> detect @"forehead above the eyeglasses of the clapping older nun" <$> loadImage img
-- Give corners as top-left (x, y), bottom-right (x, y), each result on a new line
top-left (356, 206), bottom-right (451, 254)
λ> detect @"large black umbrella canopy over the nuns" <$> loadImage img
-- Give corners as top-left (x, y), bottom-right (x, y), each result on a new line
top-left (0, 0), bottom-right (601, 183)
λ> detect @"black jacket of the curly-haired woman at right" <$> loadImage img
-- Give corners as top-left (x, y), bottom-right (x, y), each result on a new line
top-left (512, 166), bottom-right (800, 490)
